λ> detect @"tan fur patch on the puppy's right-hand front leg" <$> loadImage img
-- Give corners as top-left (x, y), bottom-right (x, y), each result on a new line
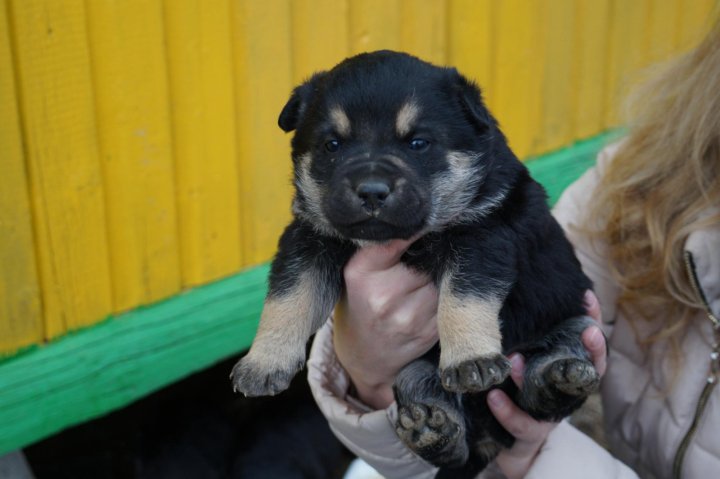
top-left (438, 274), bottom-right (502, 369)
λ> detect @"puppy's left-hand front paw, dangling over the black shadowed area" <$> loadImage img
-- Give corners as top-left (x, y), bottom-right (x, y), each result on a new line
top-left (230, 356), bottom-right (305, 397)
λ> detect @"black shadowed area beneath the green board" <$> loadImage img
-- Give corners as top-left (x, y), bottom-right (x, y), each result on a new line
top-left (24, 358), bottom-right (352, 479)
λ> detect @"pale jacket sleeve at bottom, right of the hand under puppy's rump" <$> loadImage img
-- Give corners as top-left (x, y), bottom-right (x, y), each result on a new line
top-left (525, 421), bottom-right (638, 479)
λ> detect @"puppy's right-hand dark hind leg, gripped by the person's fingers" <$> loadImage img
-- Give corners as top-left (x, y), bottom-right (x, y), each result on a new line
top-left (519, 316), bottom-right (600, 421)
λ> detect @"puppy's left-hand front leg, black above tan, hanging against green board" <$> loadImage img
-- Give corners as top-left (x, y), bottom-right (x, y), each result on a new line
top-left (231, 221), bottom-right (354, 396)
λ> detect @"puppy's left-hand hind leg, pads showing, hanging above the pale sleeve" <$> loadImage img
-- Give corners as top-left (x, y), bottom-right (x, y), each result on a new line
top-left (394, 359), bottom-right (469, 466)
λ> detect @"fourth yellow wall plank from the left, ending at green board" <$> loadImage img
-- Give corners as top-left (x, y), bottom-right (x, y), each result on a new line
top-left (165, 0), bottom-right (241, 286)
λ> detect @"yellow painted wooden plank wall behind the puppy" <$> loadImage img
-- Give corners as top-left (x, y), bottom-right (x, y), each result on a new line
top-left (0, 0), bottom-right (716, 353)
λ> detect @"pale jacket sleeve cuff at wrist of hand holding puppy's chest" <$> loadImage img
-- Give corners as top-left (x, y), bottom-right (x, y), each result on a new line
top-left (308, 320), bottom-right (437, 479)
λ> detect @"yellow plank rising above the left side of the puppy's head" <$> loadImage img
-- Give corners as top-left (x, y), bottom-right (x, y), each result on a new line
top-left (291, 0), bottom-right (350, 83)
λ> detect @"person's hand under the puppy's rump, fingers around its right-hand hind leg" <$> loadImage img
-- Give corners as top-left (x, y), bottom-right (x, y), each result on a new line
top-left (487, 291), bottom-right (607, 479)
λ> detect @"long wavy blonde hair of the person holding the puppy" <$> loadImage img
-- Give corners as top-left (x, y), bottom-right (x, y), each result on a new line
top-left (590, 21), bottom-right (720, 346)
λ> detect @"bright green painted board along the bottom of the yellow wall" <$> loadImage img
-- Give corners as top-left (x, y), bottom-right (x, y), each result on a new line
top-left (0, 130), bottom-right (614, 455)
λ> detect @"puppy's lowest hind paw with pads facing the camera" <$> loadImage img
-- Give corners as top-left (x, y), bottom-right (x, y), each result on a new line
top-left (395, 402), bottom-right (468, 466)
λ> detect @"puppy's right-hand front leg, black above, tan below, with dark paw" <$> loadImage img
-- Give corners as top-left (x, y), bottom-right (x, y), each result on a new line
top-left (438, 240), bottom-right (513, 393)
